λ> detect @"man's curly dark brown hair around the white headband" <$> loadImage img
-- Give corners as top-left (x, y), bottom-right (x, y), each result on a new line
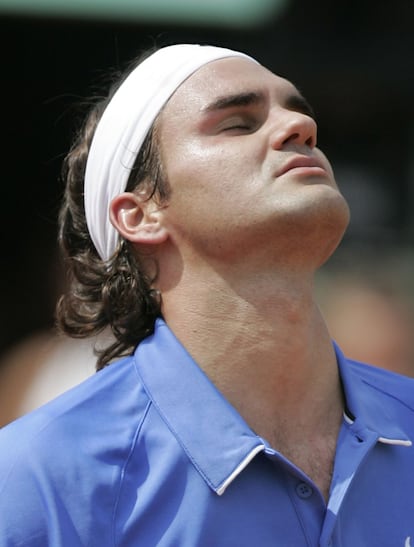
top-left (56, 59), bottom-right (170, 370)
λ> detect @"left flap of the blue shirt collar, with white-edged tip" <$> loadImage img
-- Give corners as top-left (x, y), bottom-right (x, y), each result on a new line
top-left (135, 319), bottom-right (265, 494)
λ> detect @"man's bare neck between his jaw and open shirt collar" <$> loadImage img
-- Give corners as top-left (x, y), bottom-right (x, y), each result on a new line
top-left (163, 262), bottom-right (342, 441)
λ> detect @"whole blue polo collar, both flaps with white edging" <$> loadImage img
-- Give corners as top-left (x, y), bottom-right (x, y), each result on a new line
top-left (135, 319), bottom-right (411, 495)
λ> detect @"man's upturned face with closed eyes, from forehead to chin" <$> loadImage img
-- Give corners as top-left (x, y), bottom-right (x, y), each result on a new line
top-left (155, 58), bottom-right (348, 268)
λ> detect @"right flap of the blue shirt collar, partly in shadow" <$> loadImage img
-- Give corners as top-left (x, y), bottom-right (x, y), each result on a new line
top-left (334, 344), bottom-right (412, 446)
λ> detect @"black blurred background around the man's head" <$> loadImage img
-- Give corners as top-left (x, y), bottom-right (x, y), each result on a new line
top-left (0, 0), bottom-right (414, 360)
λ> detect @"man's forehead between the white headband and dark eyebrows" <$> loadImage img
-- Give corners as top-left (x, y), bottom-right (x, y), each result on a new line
top-left (163, 57), bottom-right (298, 117)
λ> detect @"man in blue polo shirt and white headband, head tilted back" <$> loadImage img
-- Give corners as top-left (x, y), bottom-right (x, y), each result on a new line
top-left (0, 45), bottom-right (414, 547)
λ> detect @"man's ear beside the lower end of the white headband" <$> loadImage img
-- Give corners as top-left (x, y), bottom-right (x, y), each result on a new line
top-left (109, 192), bottom-right (168, 245)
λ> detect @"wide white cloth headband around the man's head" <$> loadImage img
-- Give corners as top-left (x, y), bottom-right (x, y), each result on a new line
top-left (84, 44), bottom-right (253, 260)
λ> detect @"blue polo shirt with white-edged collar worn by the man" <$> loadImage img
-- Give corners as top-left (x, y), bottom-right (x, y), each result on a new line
top-left (0, 320), bottom-right (414, 547)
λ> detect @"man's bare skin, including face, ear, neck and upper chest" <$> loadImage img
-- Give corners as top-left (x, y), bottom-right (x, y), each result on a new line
top-left (111, 58), bottom-right (349, 499)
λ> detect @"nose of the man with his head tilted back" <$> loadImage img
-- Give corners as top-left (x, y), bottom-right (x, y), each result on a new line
top-left (270, 110), bottom-right (318, 150)
